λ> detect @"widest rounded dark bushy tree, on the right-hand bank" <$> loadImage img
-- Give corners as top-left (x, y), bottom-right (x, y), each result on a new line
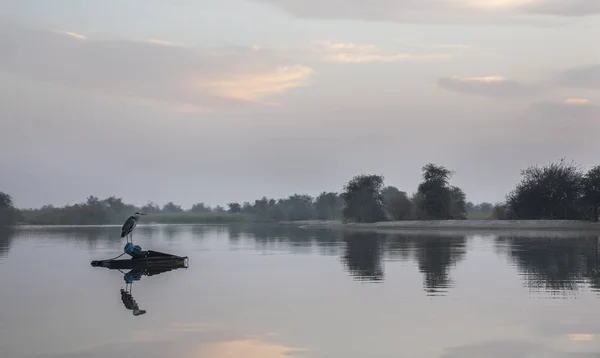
top-left (506, 159), bottom-right (584, 220)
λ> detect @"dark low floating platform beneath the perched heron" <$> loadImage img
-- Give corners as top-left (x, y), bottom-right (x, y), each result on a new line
top-left (91, 250), bottom-right (188, 270)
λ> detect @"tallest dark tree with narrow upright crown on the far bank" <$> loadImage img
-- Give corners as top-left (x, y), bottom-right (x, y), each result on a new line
top-left (417, 163), bottom-right (454, 220)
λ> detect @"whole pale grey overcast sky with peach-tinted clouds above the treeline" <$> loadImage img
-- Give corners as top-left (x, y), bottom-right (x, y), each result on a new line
top-left (0, 0), bottom-right (600, 208)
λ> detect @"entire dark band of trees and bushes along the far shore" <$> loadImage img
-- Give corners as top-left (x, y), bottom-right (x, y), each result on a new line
top-left (0, 160), bottom-right (600, 230)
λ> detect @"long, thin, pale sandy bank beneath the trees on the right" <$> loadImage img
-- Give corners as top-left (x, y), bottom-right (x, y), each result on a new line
top-left (278, 220), bottom-right (600, 234)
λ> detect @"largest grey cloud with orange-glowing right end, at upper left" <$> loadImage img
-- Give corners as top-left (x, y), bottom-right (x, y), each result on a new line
top-left (0, 19), bottom-right (314, 111)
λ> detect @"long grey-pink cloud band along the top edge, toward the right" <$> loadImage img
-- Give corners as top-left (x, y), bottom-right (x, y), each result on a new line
top-left (254, 0), bottom-right (600, 24)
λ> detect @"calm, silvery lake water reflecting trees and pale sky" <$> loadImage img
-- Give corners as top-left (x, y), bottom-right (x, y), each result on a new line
top-left (0, 225), bottom-right (600, 358)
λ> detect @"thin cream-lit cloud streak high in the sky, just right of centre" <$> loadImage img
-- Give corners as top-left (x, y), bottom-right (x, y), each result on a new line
top-left (314, 41), bottom-right (452, 63)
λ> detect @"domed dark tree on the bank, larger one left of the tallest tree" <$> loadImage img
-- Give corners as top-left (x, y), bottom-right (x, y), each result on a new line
top-left (341, 174), bottom-right (385, 223)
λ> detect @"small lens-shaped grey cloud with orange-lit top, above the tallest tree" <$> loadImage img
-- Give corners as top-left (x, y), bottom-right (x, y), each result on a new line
top-left (438, 75), bottom-right (536, 99)
